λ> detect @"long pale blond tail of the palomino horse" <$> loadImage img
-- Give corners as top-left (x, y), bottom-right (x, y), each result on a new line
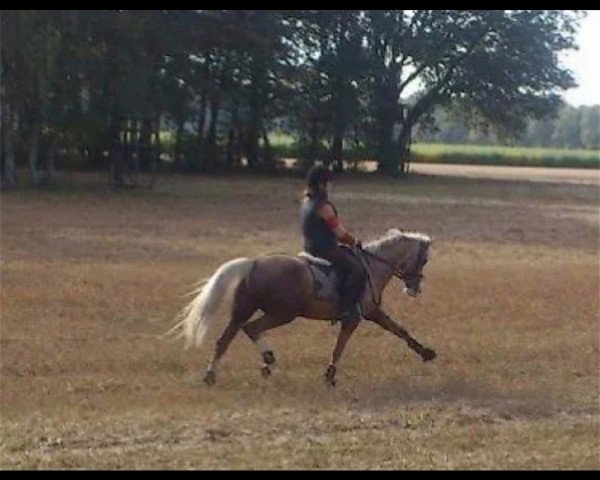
top-left (167, 258), bottom-right (254, 348)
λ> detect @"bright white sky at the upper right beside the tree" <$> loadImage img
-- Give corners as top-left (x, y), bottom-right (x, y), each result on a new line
top-left (561, 10), bottom-right (600, 107)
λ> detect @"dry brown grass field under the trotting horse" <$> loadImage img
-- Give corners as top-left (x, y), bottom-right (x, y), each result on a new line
top-left (0, 169), bottom-right (600, 470)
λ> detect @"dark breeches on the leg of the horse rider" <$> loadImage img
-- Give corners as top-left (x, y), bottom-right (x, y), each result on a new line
top-left (318, 247), bottom-right (366, 310)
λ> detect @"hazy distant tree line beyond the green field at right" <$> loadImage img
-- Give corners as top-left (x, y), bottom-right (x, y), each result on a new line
top-left (414, 105), bottom-right (600, 150)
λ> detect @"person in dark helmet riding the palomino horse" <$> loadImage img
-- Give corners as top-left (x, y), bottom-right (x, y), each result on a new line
top-left (300, 165), bottom-right (366, 322)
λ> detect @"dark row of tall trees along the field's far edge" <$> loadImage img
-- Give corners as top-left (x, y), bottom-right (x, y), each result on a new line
top-left (0, 10), bottom-right (582, 188)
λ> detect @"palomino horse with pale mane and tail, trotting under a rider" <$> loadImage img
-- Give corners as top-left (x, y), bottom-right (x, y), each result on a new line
top-left (170, 229), bottom-right (436, 385)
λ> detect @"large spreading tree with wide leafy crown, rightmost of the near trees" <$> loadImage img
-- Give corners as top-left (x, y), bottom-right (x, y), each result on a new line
top-left (367, 10), bottom-right (581, 175)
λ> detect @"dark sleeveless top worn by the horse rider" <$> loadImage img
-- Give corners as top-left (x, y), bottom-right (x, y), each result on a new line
top-left (300, 197), bottom-right (337, 256)
